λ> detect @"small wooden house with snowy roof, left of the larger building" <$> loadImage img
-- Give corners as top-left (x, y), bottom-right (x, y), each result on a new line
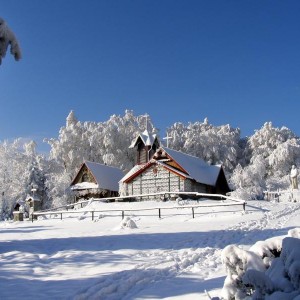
top-left (70, 161), bottom-right (124, 200)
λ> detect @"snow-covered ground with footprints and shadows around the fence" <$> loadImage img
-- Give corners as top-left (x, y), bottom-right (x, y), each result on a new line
top-left (0, 201), bottom-right (300, 299)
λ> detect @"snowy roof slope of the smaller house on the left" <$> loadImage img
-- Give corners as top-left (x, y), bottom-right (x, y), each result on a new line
top-left (80, 161), bottom-right (124, 191)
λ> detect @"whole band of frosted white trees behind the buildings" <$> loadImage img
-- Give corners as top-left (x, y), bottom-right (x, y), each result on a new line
top-left (0, 110), bottom-right (300, 220)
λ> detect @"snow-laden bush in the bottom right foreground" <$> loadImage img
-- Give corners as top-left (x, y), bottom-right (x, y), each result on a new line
top-left (222, 228), bottom-right (300, 300)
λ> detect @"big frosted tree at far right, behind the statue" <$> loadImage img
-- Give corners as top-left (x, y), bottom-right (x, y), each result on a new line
top-left (230, 122), bottom-right (300, 199)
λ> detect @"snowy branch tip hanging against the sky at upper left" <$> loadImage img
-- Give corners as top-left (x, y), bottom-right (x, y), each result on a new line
top-left (0, 17), bottom-right (22, 65)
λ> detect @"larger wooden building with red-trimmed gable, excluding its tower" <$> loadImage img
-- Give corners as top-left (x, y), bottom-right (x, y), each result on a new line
top-left (120, 147), bottom-right (230, 196)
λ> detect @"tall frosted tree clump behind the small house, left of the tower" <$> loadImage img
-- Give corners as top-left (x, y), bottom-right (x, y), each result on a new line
top-left (46, 110), bottom-right (156, 204)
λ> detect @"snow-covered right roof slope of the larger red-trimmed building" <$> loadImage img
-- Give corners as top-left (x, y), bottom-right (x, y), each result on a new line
top-left (162, 147), bottom-right (221, 186)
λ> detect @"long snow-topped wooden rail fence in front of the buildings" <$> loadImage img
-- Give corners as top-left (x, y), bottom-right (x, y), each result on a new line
top-left (31, 192), bottom-right (246, 222)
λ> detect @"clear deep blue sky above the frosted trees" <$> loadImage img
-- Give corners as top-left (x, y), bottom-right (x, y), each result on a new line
top-left (0, 0), bottom-right (300, 152)
